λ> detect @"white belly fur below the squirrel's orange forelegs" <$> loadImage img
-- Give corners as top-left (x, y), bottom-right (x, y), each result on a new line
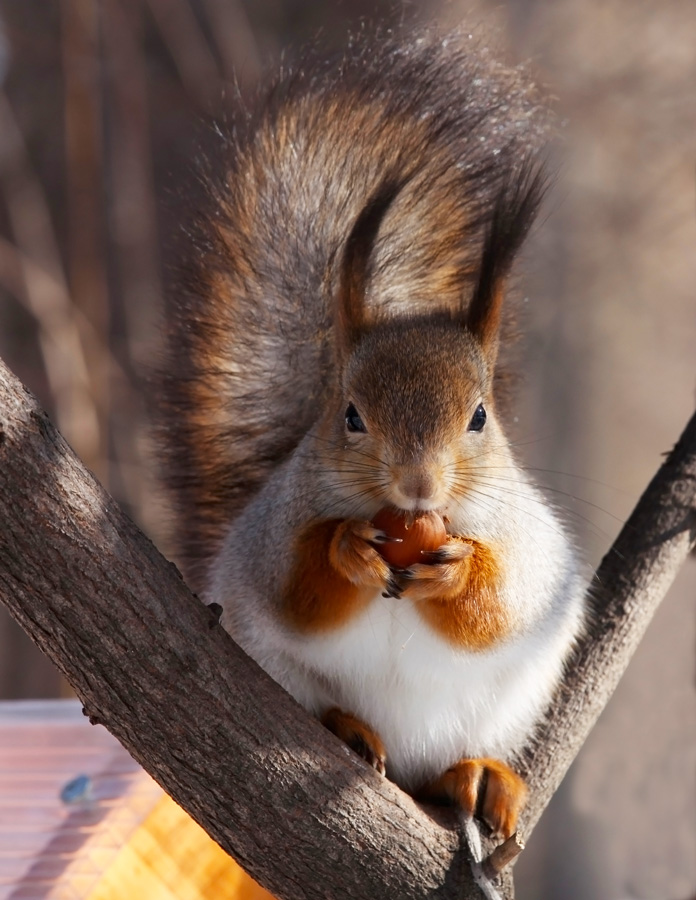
top-left (246, 595), bottom-right (568, 790)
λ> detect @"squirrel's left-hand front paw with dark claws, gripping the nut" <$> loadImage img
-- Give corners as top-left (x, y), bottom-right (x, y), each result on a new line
top-left (329, 519), bottom-right (399, 595)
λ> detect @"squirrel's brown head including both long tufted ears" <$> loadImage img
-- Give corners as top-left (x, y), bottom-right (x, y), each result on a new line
top-left (326, 166), bottom-right (543, 514)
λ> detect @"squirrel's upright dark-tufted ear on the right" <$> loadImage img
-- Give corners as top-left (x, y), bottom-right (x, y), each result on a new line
top-left (464, 161), bottom-right (548, 367)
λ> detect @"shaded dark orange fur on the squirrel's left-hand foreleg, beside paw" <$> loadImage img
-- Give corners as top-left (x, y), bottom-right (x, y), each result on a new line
top-left (282, 519), bottom-right (374, 633)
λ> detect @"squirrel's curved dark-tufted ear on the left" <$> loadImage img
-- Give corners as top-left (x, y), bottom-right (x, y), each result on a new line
top-left (335, 178), bottom-right (404, 357)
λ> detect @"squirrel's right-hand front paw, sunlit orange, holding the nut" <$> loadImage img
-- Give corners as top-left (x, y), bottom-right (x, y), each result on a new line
top-left (396, 537), bottom-right (474, 600)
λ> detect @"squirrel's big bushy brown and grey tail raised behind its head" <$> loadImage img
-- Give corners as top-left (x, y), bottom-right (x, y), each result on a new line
top-left (159, 29), bottom-right (545, 589)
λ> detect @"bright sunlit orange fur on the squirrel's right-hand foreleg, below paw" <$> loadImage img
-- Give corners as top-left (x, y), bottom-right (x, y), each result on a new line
top-left (414, 540), bottom-right (512, 650)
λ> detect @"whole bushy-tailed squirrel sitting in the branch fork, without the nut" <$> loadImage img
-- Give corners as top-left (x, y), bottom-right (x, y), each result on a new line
top-left (156, 29), bottom-right (584, 838)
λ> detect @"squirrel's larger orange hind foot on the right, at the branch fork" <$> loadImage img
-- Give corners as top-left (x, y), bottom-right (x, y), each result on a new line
top-left (418, 759), bottom-right (527, 840)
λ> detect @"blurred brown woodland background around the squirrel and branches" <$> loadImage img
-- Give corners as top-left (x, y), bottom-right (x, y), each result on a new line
top-left (0, 0), bottom-right (696, 900)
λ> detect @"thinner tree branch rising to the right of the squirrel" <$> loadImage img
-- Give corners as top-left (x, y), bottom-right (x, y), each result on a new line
top-left (520, 414), bottom-right (696, 834)
